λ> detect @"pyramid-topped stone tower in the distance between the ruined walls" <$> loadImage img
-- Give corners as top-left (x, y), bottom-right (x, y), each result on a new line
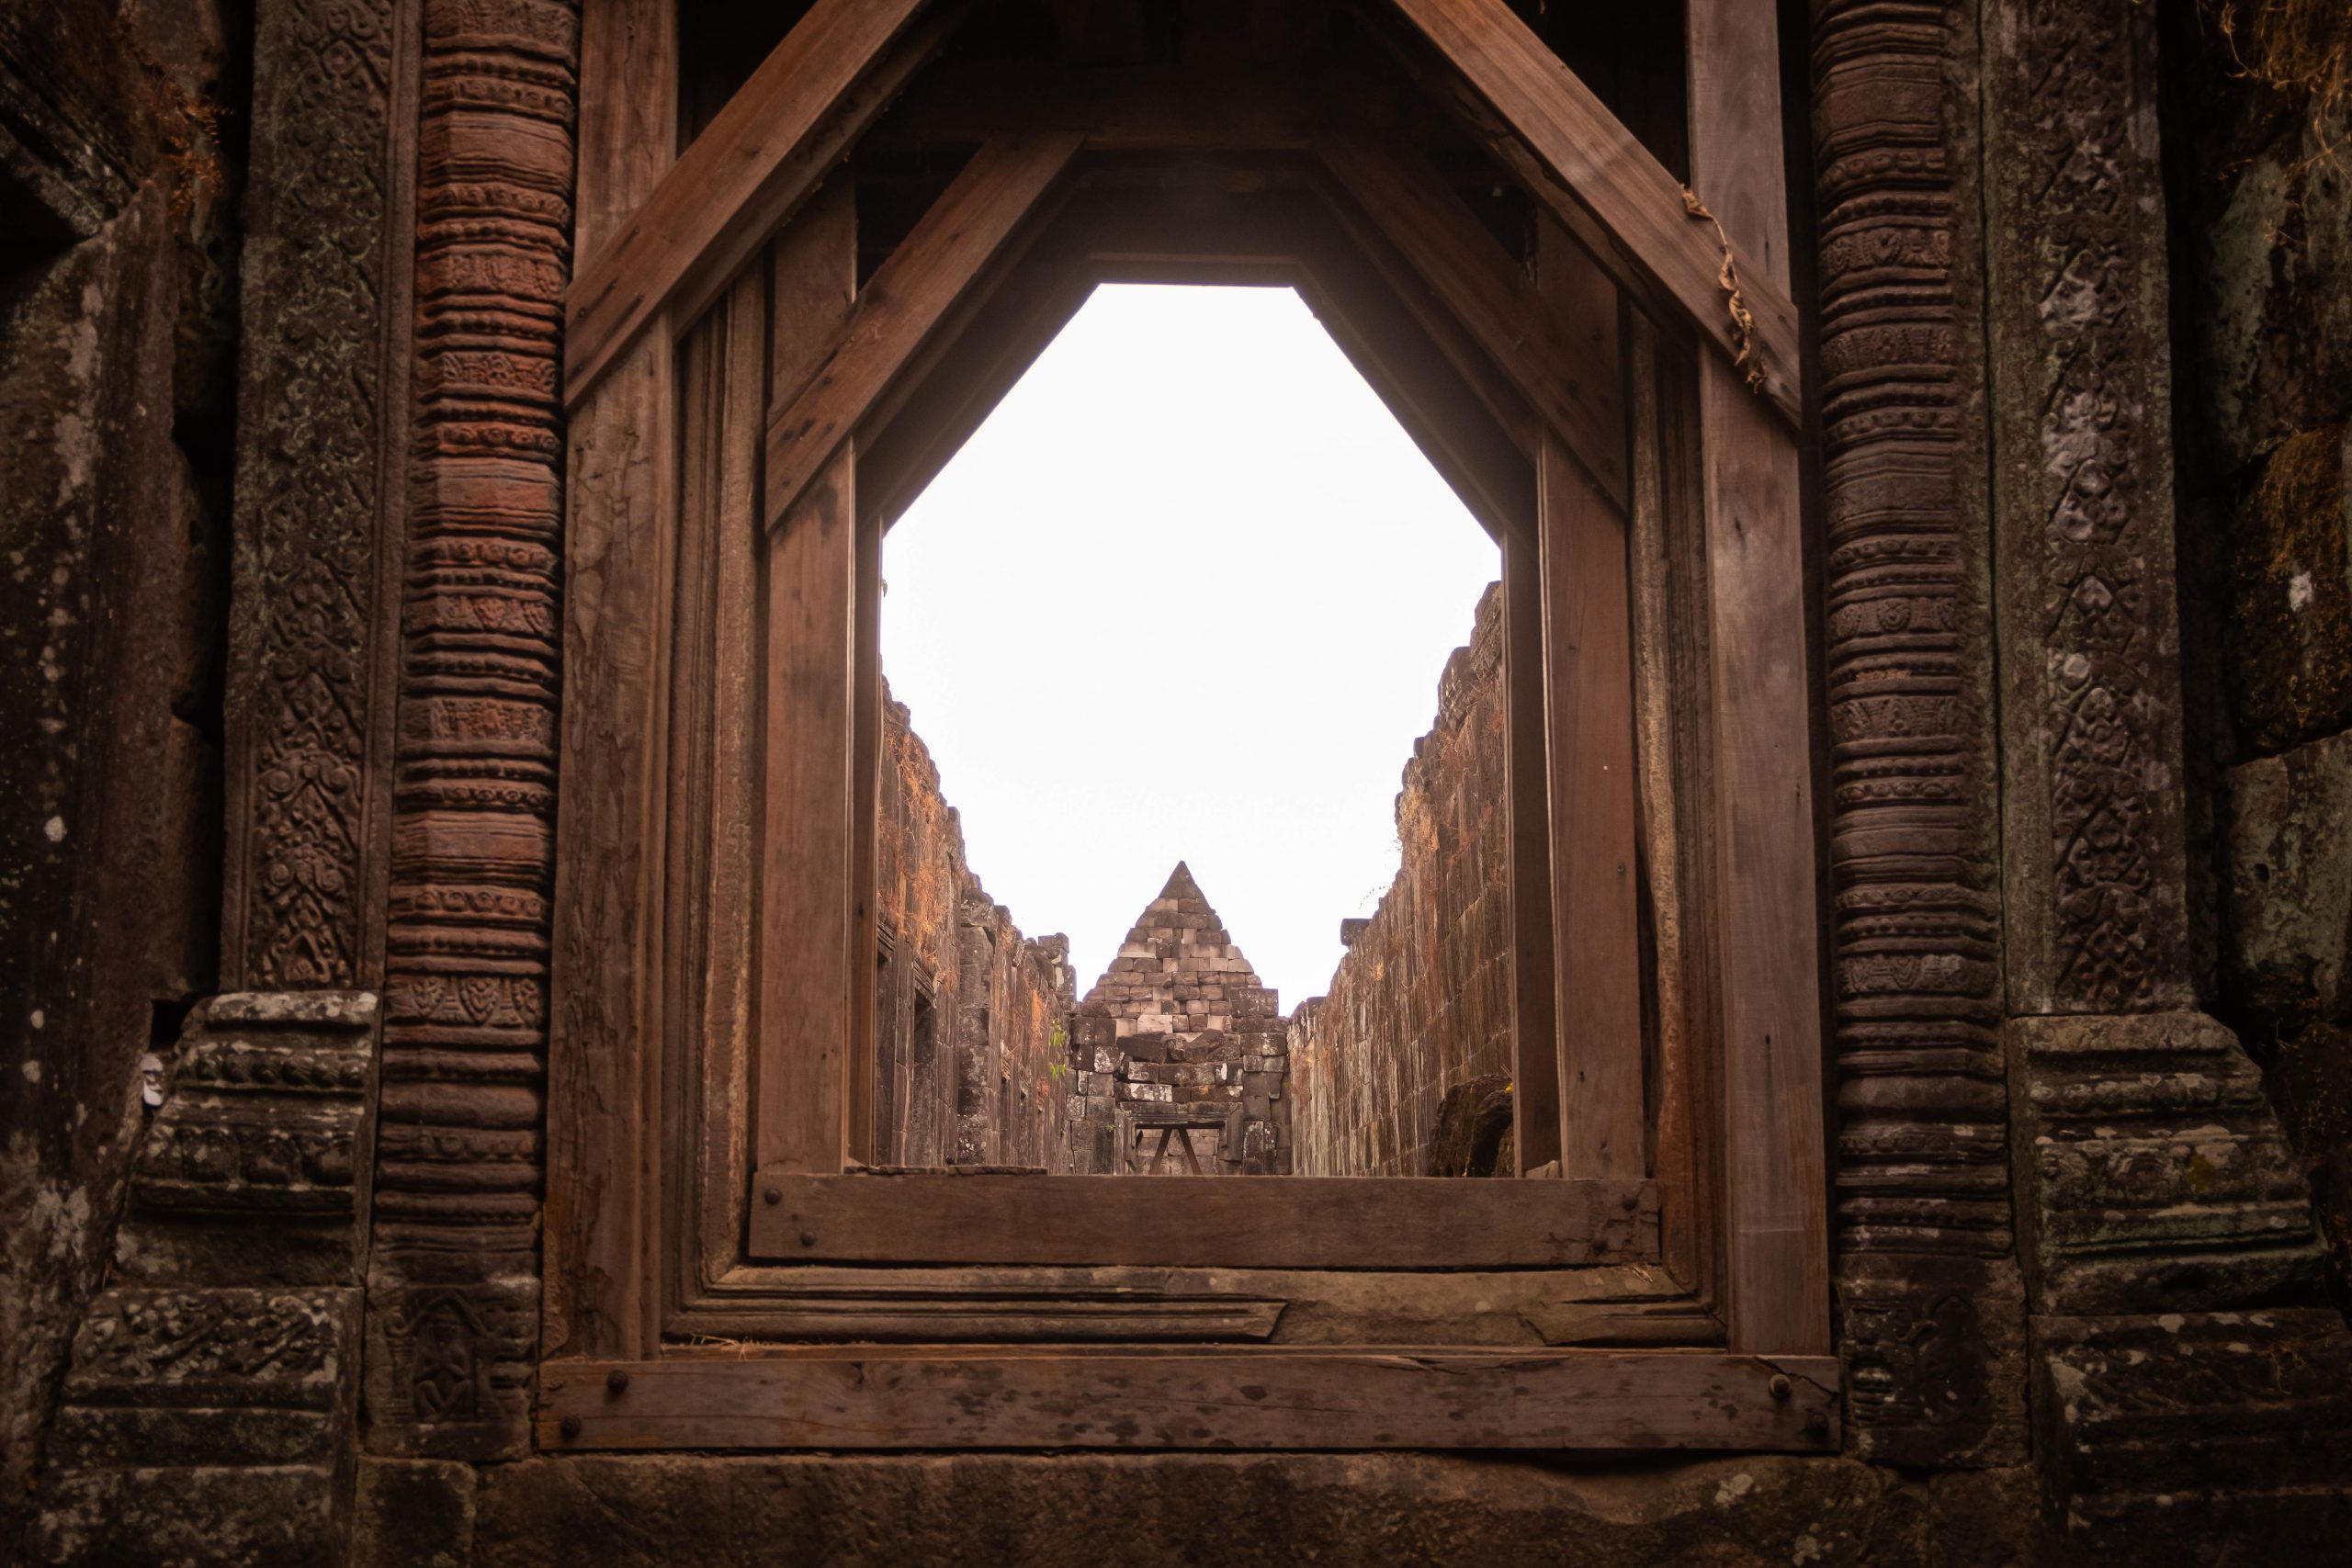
top-left (1070, 861), bottom-right (1291, 1176)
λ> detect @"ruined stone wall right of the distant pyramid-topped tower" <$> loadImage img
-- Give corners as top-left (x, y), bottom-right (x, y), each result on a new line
top-left (1289, 583), bottom-right (1510, 1176)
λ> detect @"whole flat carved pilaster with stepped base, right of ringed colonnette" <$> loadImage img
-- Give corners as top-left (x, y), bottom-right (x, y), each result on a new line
top-left (1983, 0), bottom-right (2352, 1550)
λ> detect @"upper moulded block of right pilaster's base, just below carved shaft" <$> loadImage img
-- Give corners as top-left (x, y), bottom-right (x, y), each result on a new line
top-left (2008, 1013), bottom-right (2322, 1314)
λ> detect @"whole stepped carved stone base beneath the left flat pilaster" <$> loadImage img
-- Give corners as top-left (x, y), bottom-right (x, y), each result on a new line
top-left (33, 992), bottom-right (379, 1568)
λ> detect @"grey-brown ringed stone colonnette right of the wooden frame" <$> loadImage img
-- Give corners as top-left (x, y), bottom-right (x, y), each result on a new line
top-left (1814, 0), bottom-right (2025, 1464)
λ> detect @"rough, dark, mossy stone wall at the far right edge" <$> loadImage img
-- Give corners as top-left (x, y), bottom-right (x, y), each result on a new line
top-left (2166, 5), bottom-right (2352, 1293)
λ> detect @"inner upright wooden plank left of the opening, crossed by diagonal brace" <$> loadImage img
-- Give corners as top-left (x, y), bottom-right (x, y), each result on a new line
top-left (755, 186), bottom-right (870, 1170)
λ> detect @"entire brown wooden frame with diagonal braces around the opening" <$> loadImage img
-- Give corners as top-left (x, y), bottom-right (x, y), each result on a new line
top-left (538, 0), bottom-right (1837, 1448)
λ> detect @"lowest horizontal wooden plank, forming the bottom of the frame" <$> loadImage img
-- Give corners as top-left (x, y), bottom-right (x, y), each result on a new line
top-left (538, 1344), bottom-right (1837, 1453)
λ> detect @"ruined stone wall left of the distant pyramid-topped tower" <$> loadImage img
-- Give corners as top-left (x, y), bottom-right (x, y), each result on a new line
top-left (873, 703), bottom-right (1072, 1173)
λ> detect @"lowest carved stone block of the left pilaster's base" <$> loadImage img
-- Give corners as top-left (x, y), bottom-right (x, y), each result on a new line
top-left (30, 1288), bottom-right (360, 1568)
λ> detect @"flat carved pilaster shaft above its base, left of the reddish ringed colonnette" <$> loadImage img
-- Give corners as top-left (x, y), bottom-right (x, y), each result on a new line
top-left (221, 0), bottom-right (416, 989)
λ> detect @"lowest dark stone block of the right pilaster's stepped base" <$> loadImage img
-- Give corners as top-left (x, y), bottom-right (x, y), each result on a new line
top-left (2034, 1307), bottom-right (2352, 1563)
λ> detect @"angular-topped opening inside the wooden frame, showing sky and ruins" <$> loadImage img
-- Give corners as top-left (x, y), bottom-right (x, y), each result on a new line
top-left (870, 285), bottom-right (1510, 1176)
